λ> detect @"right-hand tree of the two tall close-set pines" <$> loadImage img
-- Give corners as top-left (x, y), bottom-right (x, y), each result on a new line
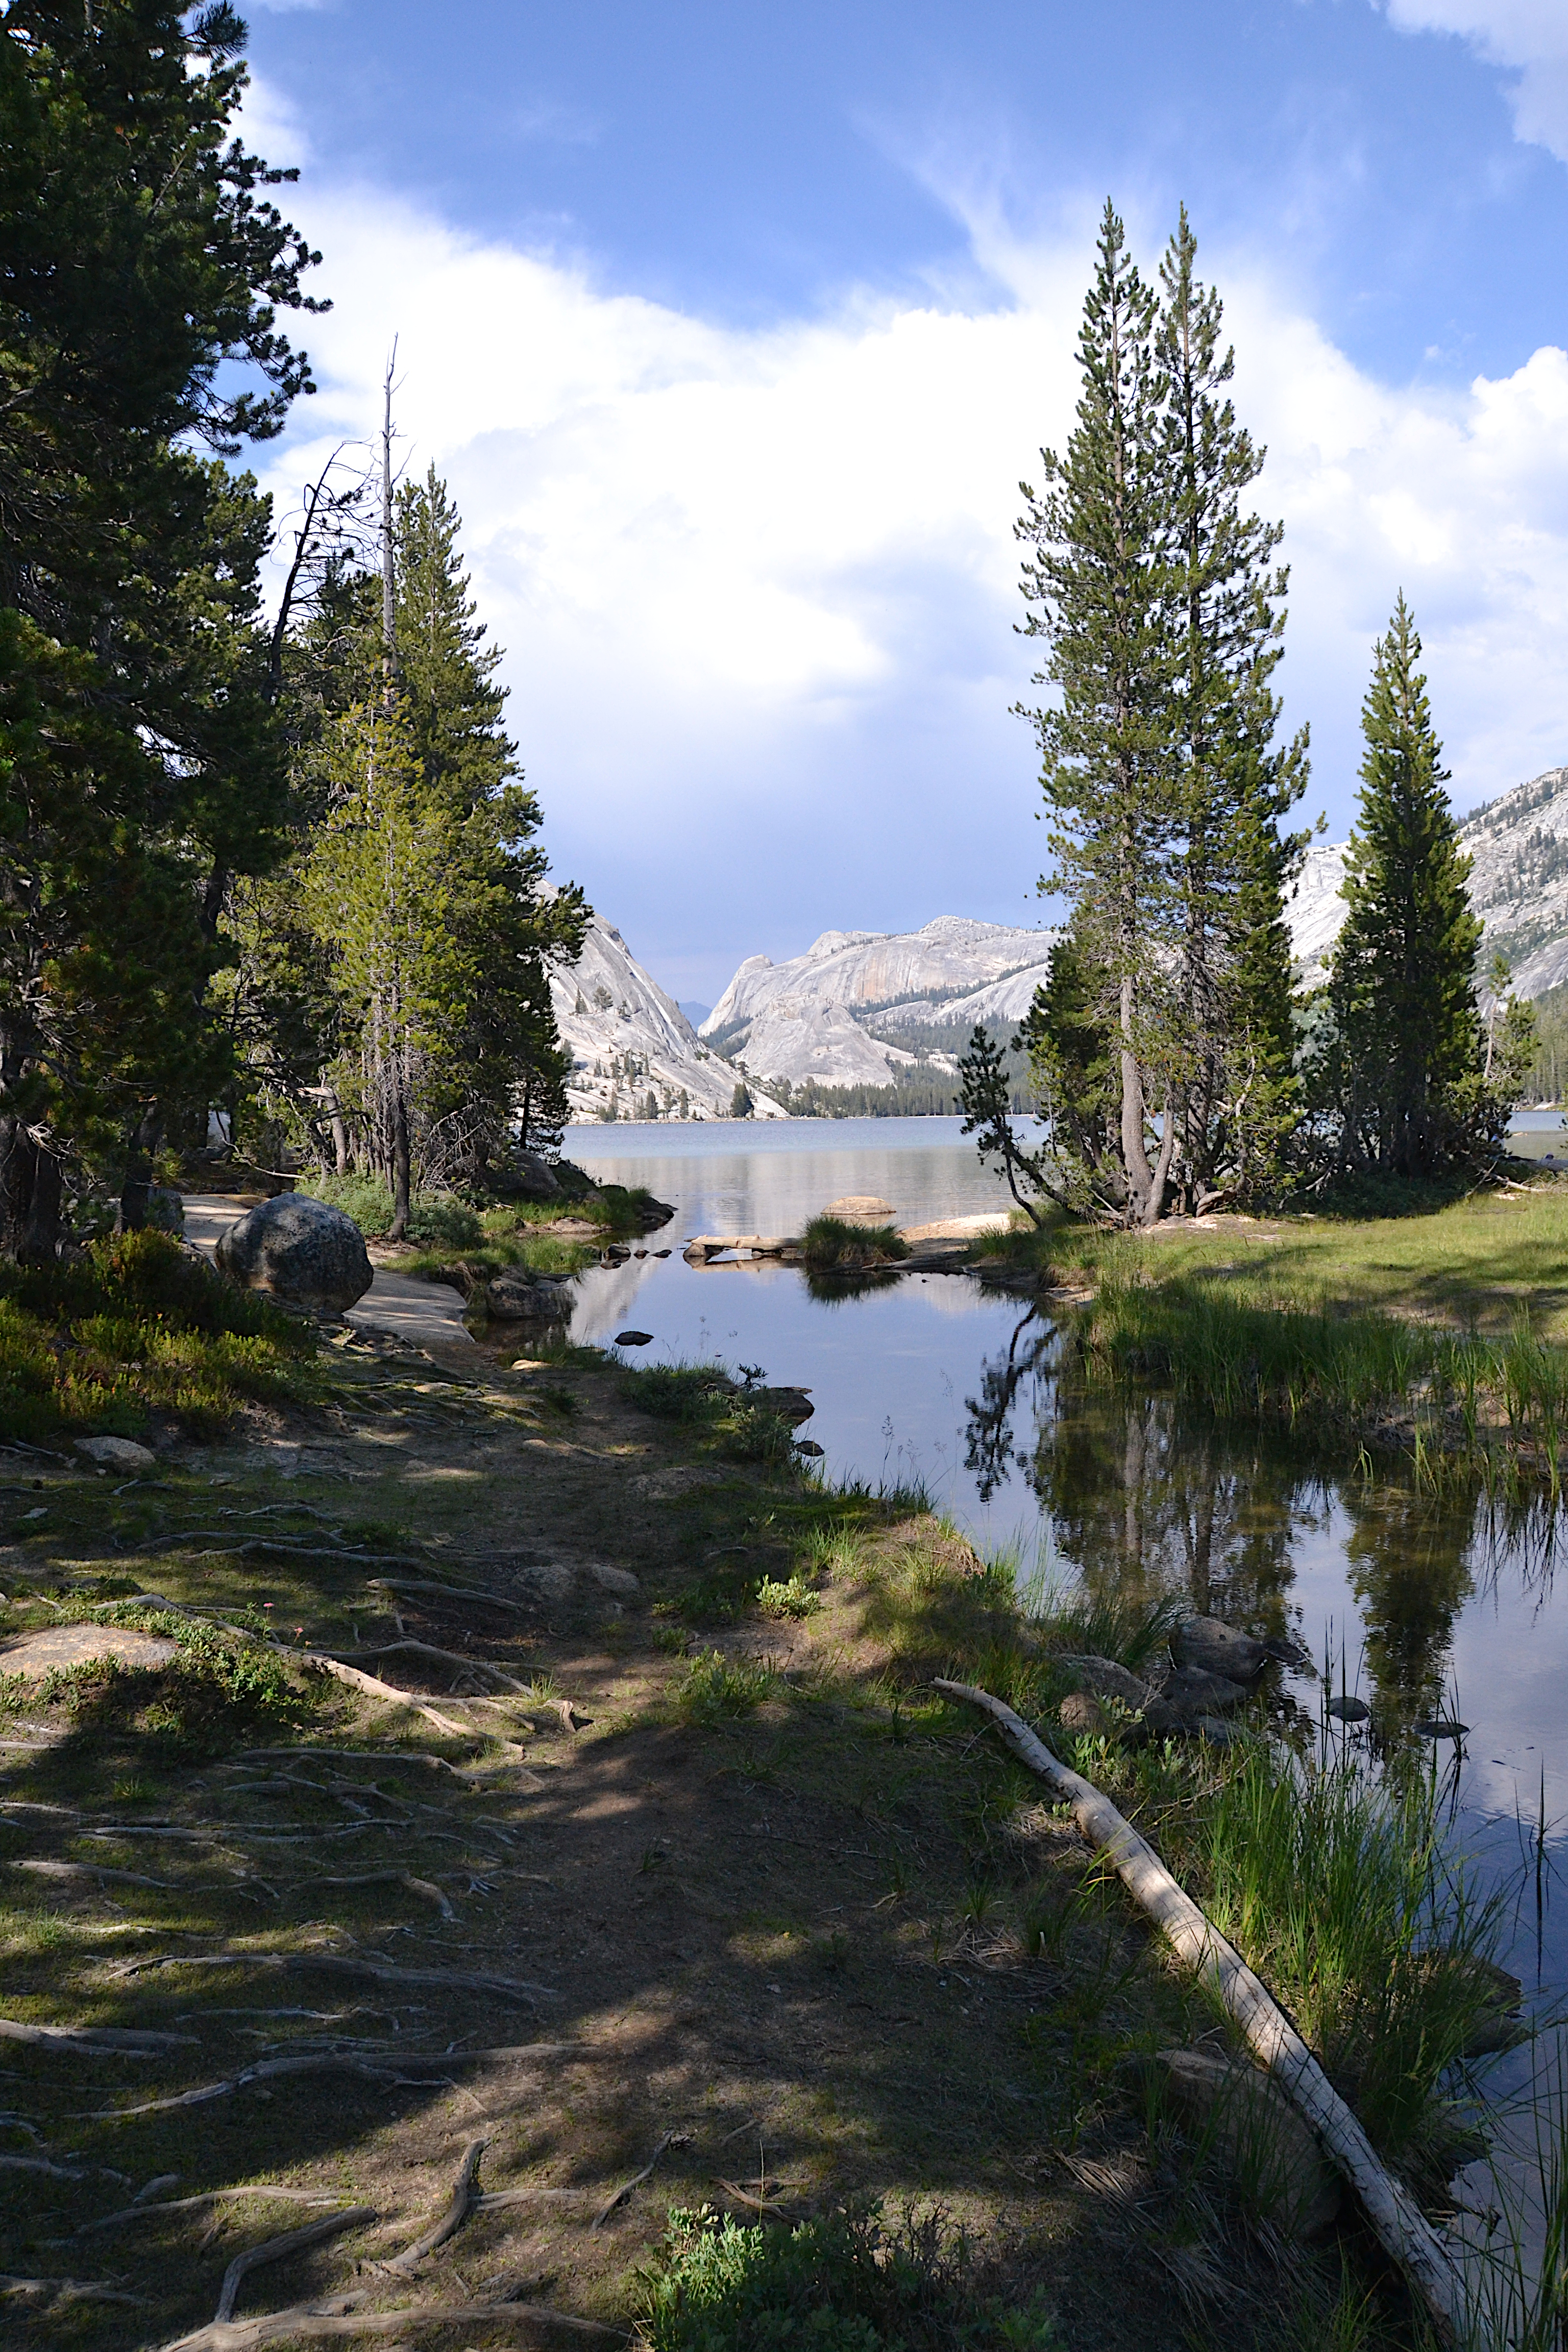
top-left (1157, 205), bottom-right (1307, 1214)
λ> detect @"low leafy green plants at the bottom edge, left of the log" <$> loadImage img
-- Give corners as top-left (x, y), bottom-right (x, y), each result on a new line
top-left (642, 2206), bottom-right (1063, 2352)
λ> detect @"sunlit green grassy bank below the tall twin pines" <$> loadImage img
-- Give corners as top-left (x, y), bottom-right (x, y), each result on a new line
top-left (987, 1181), bottom-right (1568, 1493)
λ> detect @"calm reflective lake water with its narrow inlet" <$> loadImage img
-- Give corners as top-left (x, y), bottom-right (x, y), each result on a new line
top-left (564, 1113), bottom-right (1568, 2220)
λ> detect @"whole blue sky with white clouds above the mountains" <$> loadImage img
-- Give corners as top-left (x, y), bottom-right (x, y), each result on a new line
top-left (249, 0), bottom-right (1568, 999)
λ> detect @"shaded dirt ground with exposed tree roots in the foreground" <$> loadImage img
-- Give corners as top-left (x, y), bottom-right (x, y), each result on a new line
top-left (0, 1343), bottom-right (1297, 2352)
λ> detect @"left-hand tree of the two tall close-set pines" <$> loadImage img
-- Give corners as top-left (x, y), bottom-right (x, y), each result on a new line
top-left (1018, 202), bottom-right (1180, 1226)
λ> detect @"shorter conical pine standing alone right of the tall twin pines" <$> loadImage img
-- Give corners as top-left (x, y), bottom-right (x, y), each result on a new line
top-left (1321, 593), bottom-right (1495, 1176)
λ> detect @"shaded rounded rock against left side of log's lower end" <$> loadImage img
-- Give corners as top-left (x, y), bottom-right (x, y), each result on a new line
top-left (1149, 2049), bottom-right (1340, 2237)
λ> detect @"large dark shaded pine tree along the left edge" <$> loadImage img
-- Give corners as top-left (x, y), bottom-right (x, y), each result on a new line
top-left (0, 0), bottom-right (317, 1258)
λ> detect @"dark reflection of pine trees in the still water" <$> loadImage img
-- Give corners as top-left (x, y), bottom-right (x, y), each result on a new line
top-left (966, 1308), bottom-right (1556, 1741)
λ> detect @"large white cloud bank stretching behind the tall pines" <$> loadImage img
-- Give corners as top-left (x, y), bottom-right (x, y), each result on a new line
top-left (261, 106), bottom-right (1568, 995)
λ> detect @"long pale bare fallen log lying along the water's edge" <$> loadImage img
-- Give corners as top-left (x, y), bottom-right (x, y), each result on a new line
top-left (936, 1677), bottom-right (1469, 2343)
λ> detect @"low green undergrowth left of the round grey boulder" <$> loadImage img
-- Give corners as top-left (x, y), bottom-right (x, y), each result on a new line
top-left (0, 1230), bottom-right (322, 1439)
